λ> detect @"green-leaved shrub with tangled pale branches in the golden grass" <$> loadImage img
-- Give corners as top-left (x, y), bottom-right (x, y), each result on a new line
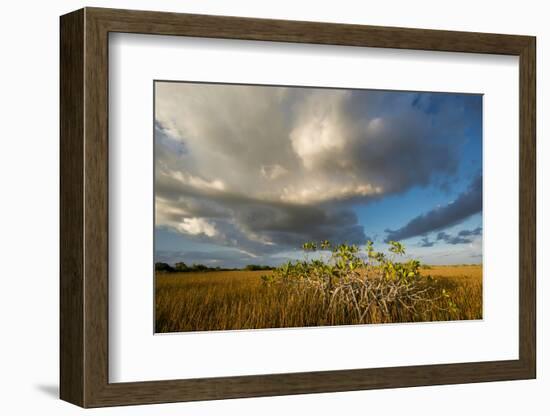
top-left (262, 241), bottom-right (455, 323)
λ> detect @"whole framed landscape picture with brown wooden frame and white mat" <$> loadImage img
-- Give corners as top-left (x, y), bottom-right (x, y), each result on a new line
top-left (60, 8), bottom-right (536, 407)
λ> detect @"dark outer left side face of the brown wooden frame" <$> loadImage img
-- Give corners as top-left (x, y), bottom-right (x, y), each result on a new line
top-left (59, 10), bottom-right (85, 406)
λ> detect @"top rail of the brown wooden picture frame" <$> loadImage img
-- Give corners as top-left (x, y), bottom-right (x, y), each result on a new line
top-left (86, 8), bottom-right (529, 55)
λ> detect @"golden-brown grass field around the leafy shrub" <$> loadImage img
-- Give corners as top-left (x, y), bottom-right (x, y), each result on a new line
top-left (155, 265), bottom-right (482, 332)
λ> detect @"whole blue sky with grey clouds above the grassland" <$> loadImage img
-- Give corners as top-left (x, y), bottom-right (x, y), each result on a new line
top-left (154, 81), bottom-right (483, 267)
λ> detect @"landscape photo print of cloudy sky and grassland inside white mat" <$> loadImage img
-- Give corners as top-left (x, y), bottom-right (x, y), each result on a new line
top-left (154, 81), bottom-right (483, 333)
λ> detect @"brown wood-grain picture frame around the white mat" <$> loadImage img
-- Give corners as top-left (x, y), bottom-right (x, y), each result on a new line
top-left (60, 8), bottom-right (536, 407)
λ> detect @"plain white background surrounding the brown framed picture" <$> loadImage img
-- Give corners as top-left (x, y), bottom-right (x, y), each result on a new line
top-left (0, 0), bottom-right (550, 416)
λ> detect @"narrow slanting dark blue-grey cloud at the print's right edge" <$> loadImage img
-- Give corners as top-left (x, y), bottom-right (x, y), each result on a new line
top-left (386, 175), bottom-right (482, 241)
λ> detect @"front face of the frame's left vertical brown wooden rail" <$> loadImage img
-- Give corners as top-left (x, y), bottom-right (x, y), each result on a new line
top-left (84, 11), bottom-right (109, 406)
